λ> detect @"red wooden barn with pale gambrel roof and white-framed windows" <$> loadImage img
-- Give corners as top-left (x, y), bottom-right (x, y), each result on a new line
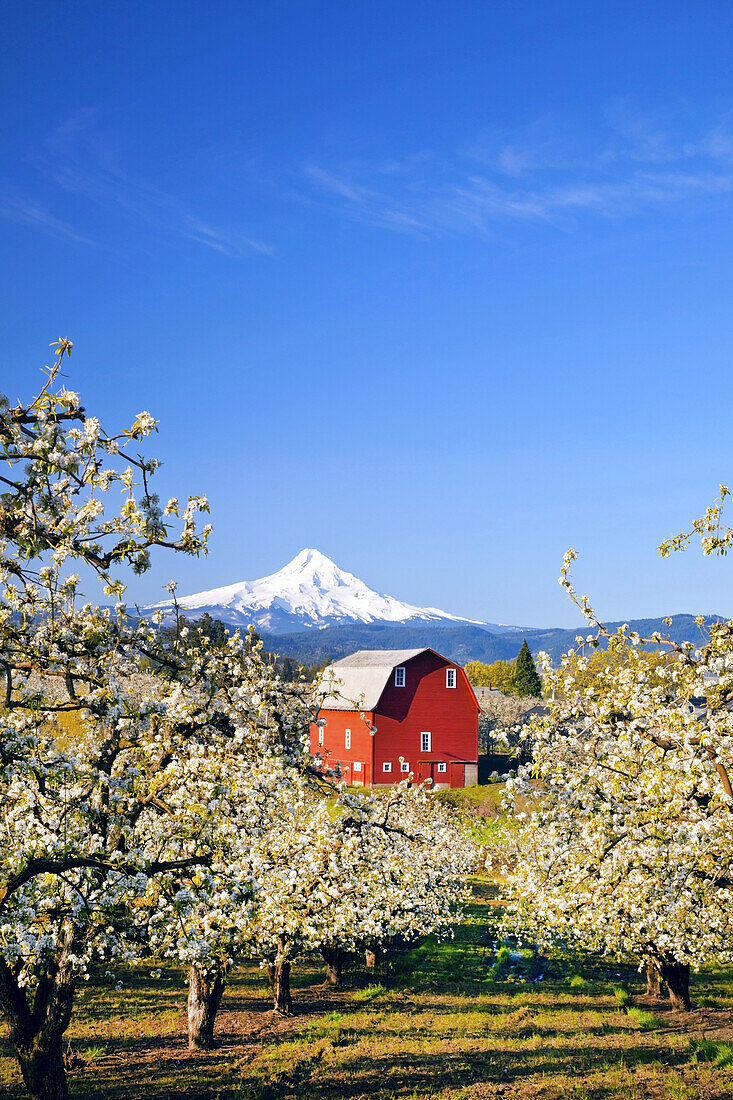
top-left (310, 649), bottom-right (480, 788)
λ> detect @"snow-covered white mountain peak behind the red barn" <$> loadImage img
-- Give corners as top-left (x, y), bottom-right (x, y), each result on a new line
top-left (145, 550), bottom-right (482, 634)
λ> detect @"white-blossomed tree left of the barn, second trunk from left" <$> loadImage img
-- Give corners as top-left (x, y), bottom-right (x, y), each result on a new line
top-left (134, 628), bottom-right (319, 1047)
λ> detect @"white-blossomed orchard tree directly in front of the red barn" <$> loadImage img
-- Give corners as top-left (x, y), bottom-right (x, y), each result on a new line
top-left (239, 783), bottom-right (475, 1015)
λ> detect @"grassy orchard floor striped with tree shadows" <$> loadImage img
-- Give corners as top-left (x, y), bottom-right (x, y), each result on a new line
top-left (0, 881), bottom-right (733, 1100)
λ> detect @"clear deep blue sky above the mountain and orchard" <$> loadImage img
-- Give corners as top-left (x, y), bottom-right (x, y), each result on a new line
top-left (0, 0), bottom-right (733, 625)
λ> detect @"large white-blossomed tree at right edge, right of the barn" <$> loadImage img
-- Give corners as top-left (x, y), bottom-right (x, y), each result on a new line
top-left (507, 519), bottom-right (733, 1010)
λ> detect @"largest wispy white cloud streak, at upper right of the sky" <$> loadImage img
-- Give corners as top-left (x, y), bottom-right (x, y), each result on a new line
top-left (304, 109), bottom-right (733, 237)
